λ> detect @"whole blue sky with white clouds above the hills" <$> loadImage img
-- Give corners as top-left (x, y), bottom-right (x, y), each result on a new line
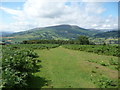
top-left (0, 0), bottom-right (118, 32)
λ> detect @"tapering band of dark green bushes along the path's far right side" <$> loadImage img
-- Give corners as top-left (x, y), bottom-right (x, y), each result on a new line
top-left (64, 45), bottom-right (120, 57)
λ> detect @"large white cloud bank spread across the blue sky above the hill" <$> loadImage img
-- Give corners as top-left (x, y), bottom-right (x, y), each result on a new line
top-left (0, 0), bottom-right (117, 31)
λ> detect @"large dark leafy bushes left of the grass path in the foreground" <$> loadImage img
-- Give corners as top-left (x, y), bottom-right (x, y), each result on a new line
top-left (2, 46), bottom-right (39, 88)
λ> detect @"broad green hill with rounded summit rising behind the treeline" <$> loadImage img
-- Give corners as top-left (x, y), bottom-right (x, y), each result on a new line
top-left (3, 25), bottom-right (100, 42)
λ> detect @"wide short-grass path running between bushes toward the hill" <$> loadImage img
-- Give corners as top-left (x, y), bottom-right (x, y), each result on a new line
top-left (27, 47), bottom-right (118, 88)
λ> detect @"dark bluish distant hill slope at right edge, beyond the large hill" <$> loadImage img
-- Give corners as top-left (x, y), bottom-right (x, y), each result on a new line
top-left (94, 31), bottom-right (120, 38)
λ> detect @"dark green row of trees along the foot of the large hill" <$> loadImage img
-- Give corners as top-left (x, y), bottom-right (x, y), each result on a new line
top-left (21, 36), bottom-right (94, 45)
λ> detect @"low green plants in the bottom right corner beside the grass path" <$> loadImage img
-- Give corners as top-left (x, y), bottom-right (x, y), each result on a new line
top-left (91, 66), bottom-right (119, 88)
